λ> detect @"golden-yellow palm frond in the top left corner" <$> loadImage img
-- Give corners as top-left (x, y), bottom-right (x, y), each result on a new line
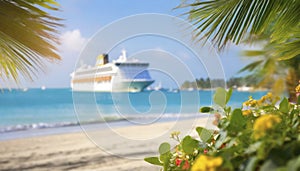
top-left (0, 0), bottom-right (62, 83)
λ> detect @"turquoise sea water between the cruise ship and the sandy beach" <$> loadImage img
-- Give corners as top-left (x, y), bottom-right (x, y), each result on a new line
top-left (0, 89), bottom-right (266, 133)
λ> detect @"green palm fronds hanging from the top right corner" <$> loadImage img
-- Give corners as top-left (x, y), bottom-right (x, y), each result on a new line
top-left (180, 0), bottom-right (300, 54)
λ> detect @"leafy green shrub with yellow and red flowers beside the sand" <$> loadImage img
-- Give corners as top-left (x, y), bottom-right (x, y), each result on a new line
top-left (145, 88), bottom-right (300, 171)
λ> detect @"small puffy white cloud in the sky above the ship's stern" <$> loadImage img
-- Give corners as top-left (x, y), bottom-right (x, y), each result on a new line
top-left (60, 29), bottom-right (87, 52)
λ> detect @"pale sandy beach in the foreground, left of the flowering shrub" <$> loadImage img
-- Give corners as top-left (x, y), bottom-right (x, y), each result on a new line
top-left (0, 118), bottom-right (213, 171)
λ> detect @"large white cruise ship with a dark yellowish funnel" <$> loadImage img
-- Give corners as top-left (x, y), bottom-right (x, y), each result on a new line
top-left (71, 50), bottom-right (154, 92)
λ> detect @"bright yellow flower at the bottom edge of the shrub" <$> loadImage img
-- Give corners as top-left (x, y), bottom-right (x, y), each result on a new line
top-left (191, 155), bottom-right (223, 171)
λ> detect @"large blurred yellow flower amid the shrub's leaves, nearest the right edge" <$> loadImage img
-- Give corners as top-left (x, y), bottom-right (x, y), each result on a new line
top-left (253, 114), bottom-right (281, 139)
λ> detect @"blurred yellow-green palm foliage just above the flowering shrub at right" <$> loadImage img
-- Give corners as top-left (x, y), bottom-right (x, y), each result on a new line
top-left (240, 46), bottom-right (300, 98)
